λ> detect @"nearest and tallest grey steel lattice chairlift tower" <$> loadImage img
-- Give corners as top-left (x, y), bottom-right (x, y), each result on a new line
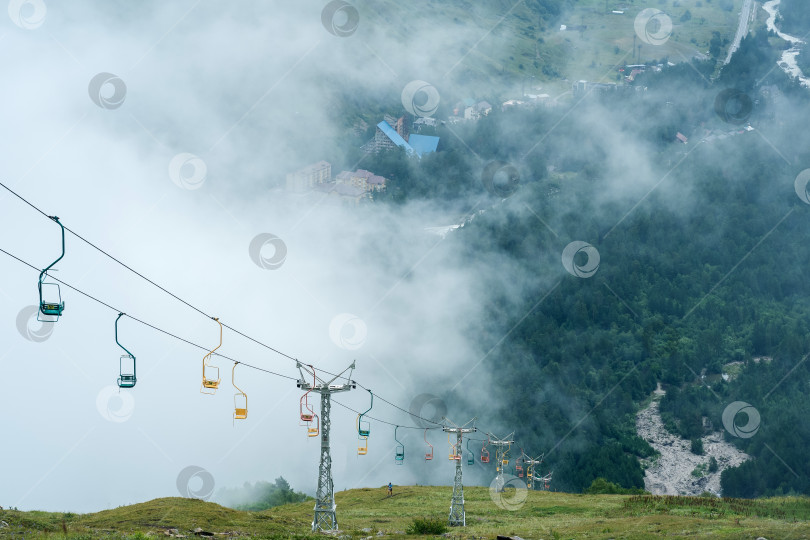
top-left (296, 362), bottom-right (357, 531)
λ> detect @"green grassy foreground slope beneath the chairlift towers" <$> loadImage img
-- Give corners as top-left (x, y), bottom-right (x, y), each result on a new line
top-left (0, 486), bottom-right (810, 539)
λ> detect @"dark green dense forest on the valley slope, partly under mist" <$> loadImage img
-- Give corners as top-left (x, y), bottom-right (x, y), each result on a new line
top-left (336, 12), bottom-right (810, 497)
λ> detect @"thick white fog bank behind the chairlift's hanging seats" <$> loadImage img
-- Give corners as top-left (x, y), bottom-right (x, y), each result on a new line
top-left (0, 0), bottom-right (532, 511)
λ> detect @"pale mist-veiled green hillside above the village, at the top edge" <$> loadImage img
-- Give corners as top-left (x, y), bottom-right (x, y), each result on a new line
top-left (359, 0), bottom-right (743, 95)
